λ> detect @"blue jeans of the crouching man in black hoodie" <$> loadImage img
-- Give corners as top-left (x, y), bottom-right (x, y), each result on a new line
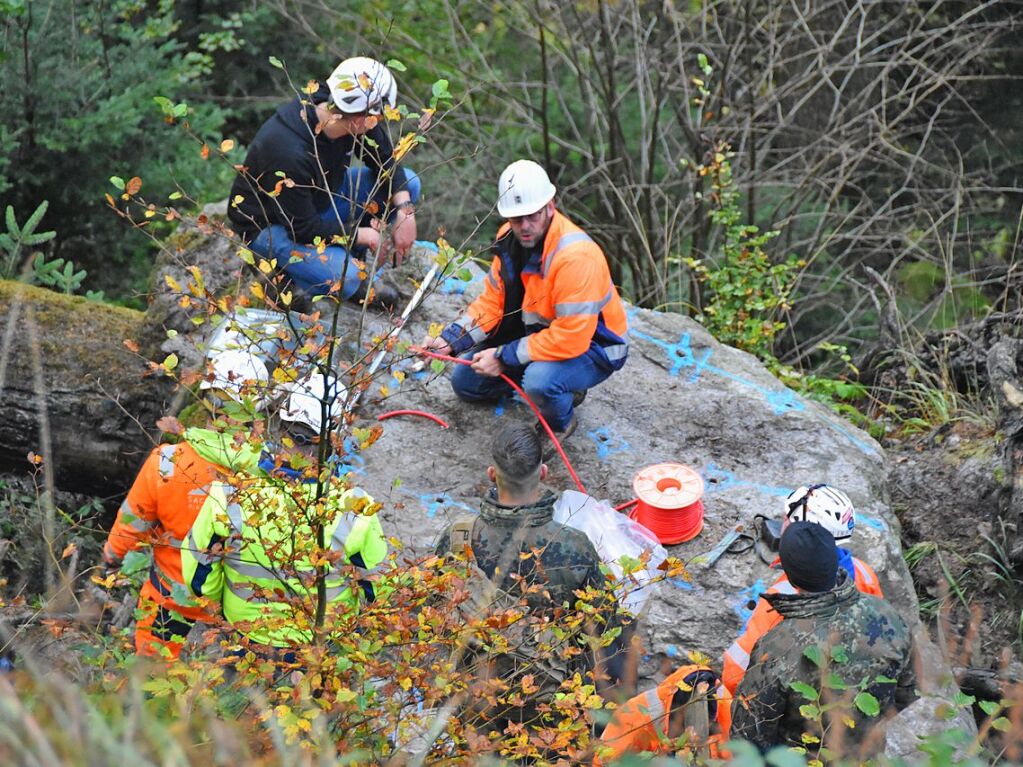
top-left (249, 167), bottom-right (421, 299)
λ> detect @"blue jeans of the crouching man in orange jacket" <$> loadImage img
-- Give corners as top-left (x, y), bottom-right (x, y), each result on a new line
top-left (451, 352), bottom-right (612, 432)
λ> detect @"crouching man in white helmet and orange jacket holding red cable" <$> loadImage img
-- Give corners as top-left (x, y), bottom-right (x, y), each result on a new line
top-left (422, 160), bottom-right (628, 437)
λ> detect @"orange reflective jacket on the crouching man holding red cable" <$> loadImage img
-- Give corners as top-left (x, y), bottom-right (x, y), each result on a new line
top-left (444, 212), bottom-right (628, 370)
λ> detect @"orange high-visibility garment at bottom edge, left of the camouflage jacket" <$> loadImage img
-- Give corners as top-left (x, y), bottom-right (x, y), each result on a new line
top-left (593, 665), bottom-right (731, 767)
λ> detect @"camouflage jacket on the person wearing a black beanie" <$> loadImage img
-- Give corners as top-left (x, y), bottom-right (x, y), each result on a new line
top-left (731, 574), bottom-right (916, 758)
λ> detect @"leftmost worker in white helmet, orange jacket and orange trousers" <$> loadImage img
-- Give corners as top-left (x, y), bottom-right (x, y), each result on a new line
top-left (103, 350), bottom-right (269, 658)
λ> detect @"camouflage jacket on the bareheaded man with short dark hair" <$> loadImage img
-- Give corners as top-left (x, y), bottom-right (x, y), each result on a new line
top-left (437, 488), bottom-right (604, 610)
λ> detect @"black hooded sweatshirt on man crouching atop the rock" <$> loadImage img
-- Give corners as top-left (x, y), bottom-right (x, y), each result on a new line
top-left (227, 85), bottom-right (405, 243)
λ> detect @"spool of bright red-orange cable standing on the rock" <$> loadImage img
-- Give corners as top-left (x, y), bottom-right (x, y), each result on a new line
top-left (629, 463), bottom-right (704, 546)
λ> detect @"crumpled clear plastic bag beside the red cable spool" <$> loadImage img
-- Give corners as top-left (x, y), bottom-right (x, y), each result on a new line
top-left (554, 490), bottom-right (668, 616)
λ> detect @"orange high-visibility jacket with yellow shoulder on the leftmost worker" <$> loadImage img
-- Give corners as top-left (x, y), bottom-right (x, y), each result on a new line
top-left (103, 428), bottom-right (259, 595)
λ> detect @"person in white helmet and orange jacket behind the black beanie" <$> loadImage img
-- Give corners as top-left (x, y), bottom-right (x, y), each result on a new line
top-left (721, 485), bottom-right (884, 694)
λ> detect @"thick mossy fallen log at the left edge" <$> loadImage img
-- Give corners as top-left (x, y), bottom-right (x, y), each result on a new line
top-left (0, 281), bottom-right (173, 497)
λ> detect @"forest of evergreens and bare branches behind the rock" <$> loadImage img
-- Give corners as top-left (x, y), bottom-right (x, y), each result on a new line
top-left (0, 0), bottom-right (1023, 396)
